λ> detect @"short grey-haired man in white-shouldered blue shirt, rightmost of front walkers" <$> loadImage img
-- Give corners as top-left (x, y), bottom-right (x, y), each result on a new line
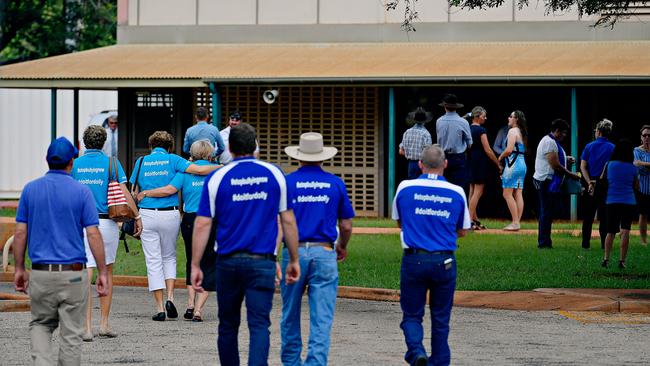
top-left (393, 145), bottom-right (471, 366)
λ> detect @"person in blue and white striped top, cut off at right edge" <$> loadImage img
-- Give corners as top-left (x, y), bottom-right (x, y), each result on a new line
top-left (634, 125), bottom-right (650, 245)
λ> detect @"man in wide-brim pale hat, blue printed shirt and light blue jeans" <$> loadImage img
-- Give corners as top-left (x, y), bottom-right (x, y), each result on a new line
top-left (280, 132), bottom-right (354, 365)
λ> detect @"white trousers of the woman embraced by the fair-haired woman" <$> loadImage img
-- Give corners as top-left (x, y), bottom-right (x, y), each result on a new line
top-left (140, 208), bottom-right (181, 291)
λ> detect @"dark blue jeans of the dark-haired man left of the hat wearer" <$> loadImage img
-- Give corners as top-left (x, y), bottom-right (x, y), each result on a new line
top-left (217, 258), bottom-right (275, 366)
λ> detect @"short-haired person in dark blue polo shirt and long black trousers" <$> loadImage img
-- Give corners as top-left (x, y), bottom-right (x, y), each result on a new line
top-left (580, 119), bottom-right (614, 249)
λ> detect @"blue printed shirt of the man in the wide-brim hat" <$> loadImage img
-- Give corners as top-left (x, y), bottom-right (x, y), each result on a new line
top-left (287, 165), bottom-right (354, 243)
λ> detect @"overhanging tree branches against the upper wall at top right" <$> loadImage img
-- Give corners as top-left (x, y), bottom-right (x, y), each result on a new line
top-left (386, 0), bottom-right (650, 32)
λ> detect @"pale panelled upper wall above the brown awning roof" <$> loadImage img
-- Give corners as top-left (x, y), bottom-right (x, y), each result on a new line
top-left (128, 0), bottom-right (593, 25)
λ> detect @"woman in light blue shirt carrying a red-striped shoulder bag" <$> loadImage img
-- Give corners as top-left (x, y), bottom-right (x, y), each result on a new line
top-left (71, 125), bottom-right (142, 342)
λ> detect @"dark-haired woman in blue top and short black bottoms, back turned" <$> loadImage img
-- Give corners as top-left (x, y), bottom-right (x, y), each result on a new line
top-left (602, 140), bottom-right (639, 269)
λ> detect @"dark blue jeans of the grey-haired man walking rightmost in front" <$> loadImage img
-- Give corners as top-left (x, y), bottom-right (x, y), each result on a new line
top-left (400, 254), bottom-right (456, 365)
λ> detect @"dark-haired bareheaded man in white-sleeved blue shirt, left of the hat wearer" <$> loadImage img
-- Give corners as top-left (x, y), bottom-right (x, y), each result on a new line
top-left (187, 123), bottom-right (300, 366)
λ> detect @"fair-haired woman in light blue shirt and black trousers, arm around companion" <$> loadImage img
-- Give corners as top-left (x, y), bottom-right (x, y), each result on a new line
top-left (138, 140), bottom-right (217, 322)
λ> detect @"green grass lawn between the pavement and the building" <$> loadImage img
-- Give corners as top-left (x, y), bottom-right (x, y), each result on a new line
top-left (115, 234), bottom-right (650, 290)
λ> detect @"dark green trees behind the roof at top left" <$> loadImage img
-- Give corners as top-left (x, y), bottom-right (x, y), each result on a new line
top-left (0, 0), bottom-right (117, 64)
